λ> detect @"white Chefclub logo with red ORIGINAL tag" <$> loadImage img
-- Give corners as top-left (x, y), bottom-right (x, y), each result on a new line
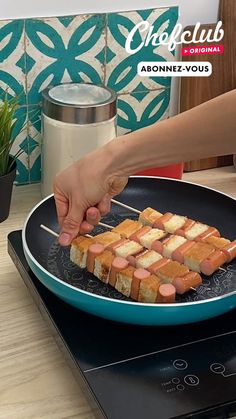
top-left (125, 21), bottom-right (224, 55)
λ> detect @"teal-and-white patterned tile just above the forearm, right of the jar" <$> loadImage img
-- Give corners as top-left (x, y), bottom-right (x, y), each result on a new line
top-left (118, 89), bottom-right (170, 135)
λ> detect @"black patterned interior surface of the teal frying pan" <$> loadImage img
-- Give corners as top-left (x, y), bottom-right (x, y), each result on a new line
top-left (26, 177), bottom-right (236, 302)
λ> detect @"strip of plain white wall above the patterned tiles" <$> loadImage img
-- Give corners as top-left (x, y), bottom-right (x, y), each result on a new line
top-left (0, 0), bottom-right (219, 25)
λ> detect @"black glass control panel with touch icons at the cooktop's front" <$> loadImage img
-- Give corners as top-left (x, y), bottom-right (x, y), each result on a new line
top-left (85, 332), bottom-right (236, 419)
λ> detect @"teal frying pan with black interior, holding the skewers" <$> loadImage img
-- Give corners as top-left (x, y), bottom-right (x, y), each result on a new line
top-left (22, 177), bottom-right (236, 325)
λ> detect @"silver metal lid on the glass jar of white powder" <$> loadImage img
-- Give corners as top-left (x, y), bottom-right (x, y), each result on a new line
top-left (42, 83), bottom-right (117, 125)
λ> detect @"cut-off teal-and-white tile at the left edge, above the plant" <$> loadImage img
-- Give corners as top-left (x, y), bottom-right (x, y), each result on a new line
top-left (0, 20), bottom-right (26, 105)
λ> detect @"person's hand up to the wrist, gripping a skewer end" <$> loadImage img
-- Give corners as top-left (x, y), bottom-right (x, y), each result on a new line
top-left (54, 151), bottom-right (128, 246)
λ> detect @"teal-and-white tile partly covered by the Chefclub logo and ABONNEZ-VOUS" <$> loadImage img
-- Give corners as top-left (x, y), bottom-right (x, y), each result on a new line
top-left (106, 7), bottom-right (178, 93)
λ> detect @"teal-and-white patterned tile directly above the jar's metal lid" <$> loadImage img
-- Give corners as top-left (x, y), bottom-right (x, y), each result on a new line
top-left (26, 14), bottom-right (105, 104)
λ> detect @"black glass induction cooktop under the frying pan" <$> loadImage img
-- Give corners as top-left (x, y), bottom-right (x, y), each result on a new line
top-left (8, 231), bottom-right (236, 419)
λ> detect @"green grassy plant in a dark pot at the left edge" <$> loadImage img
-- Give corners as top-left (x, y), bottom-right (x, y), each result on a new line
top-left (0, 95), bottom-right (23, 222)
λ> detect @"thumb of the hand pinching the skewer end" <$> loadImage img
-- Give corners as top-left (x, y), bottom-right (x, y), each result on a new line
top-left (59, 201), bottom-right (84, 246)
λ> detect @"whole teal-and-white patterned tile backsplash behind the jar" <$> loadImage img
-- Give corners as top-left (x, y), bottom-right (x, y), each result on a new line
top-left (0, 7), bottom-right (178, 183)
